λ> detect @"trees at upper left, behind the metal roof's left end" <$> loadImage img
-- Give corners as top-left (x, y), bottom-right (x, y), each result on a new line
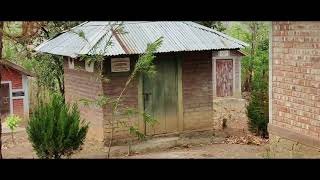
top-left (4, 21), bottom-right (81, 94)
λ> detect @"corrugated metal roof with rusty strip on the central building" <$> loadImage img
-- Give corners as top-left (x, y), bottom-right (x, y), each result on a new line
top-left (35, 21), bottom-right (248, 57)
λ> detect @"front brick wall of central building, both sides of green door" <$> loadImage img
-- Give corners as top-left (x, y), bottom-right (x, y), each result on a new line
top-left (103, 51), bottom-right (216, 142)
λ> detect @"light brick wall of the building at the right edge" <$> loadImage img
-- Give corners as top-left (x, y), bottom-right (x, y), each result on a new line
top-left (269, 22), bottom-right (320, 147)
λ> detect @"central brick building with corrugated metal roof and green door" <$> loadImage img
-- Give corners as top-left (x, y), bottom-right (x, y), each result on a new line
top-left (36, 21), bottom-right (246, 143)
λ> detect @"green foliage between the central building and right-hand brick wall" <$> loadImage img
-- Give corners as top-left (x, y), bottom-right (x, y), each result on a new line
top-left (227, 21), bottom-right (269, 137)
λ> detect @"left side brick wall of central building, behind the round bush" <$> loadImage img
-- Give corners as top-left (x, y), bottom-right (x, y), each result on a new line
top-left (64, 60), bottom-right (103, 141)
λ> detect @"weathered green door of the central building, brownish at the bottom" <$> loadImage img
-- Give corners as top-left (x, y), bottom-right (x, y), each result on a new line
top-left (143, 56), bottom-right (178, 135)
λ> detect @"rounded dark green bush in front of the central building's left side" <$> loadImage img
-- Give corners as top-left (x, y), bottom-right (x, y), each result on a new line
top-left (27, 94), bottom-right (88, 159)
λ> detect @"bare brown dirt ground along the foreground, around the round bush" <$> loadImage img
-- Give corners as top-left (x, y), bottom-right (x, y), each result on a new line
top-left (3, 132), bottom-right (266, 159)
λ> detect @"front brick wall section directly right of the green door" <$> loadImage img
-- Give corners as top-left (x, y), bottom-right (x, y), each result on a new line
top-left (182, 52), bottom-right (212, 130)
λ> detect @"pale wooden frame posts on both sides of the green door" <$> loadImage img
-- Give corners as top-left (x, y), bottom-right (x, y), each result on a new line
top-left (138, 55), bottom-right (184, 134)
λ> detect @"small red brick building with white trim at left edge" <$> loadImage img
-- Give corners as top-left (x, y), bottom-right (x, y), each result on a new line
top-left (0, 59), bottom-right (31, 120)
